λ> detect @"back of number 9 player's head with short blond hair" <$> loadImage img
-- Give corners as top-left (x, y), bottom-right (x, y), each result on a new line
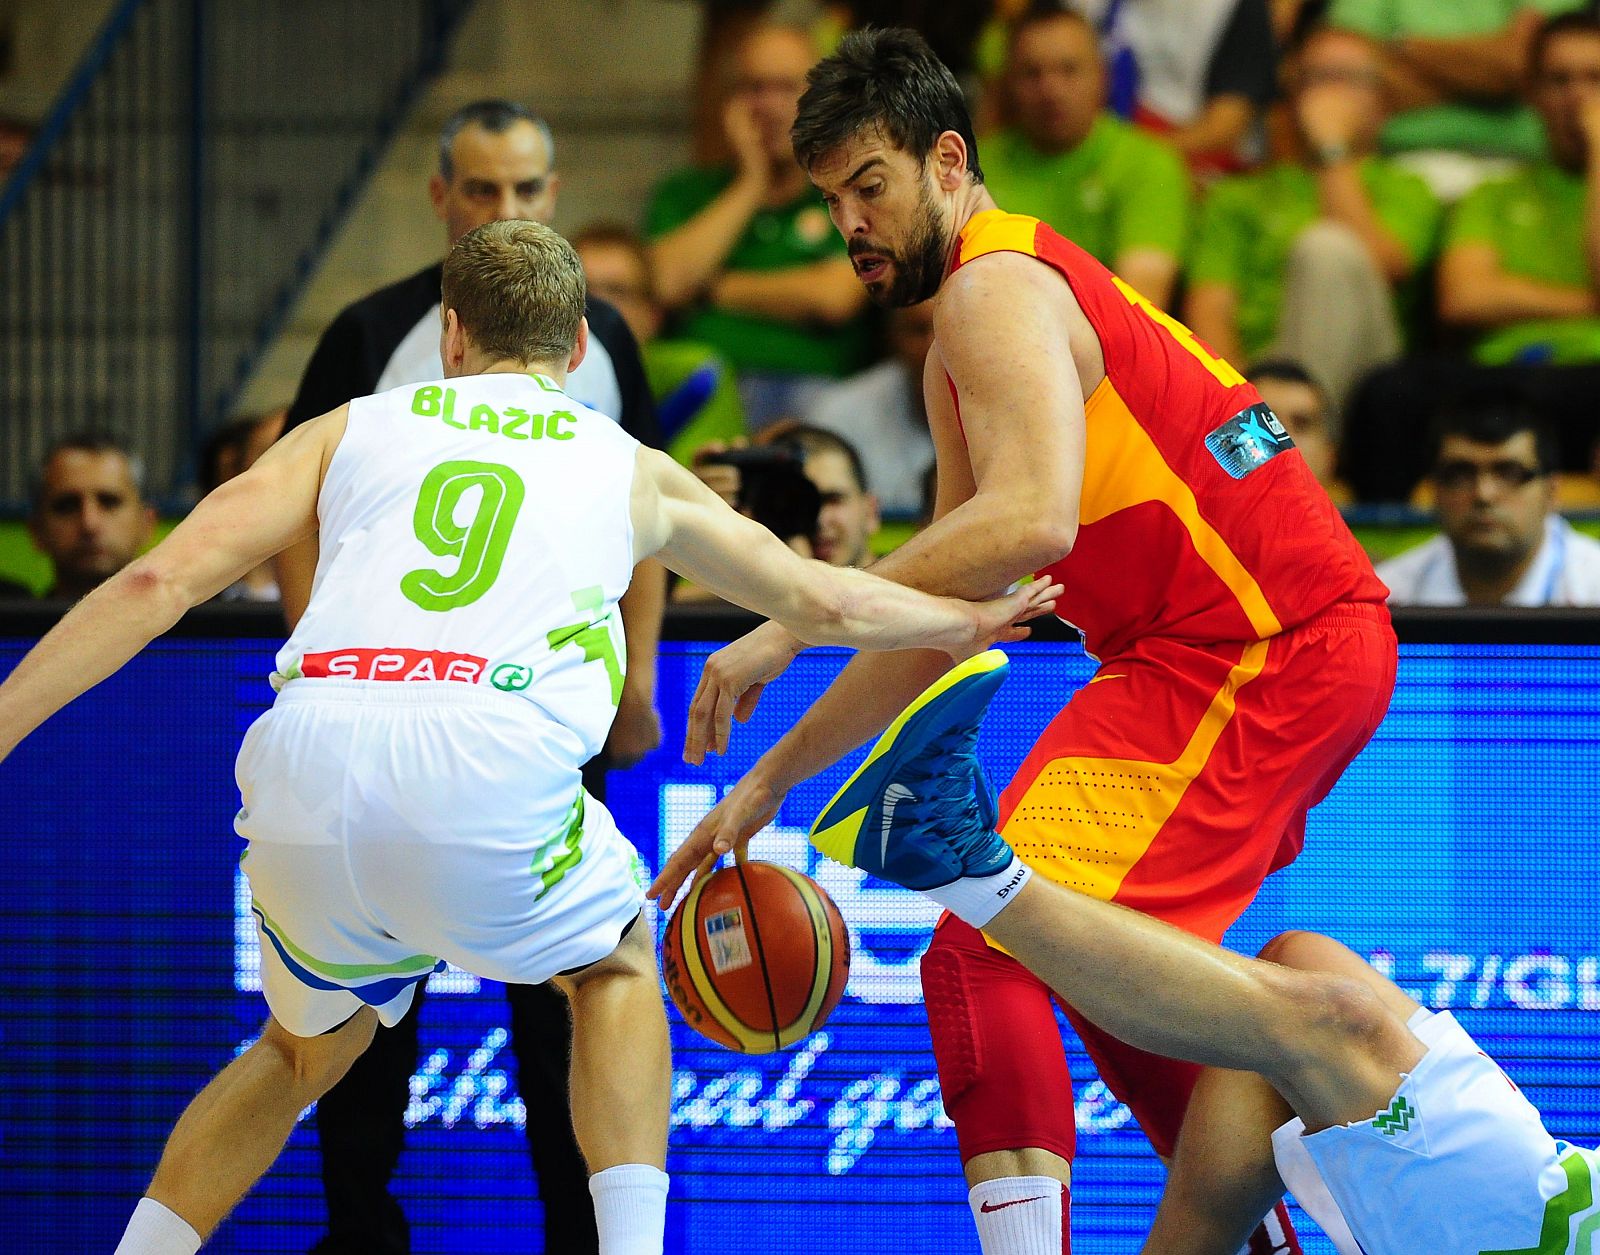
top-left (442, 221), bottom-right (584, 365)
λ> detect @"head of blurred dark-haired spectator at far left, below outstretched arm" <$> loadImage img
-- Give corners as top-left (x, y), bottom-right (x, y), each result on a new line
top-left (27, 432), bottom-right (155, 600)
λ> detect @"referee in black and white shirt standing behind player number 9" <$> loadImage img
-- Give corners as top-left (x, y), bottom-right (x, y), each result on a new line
top-left (277, 99), bottom-right (666, 1255)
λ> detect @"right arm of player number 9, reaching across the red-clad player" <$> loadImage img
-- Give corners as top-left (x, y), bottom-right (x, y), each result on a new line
top-left (634, 448), bottom-right (1059, 655)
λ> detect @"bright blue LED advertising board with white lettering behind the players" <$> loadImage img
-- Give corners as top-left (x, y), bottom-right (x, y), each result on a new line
top-left (0, 640), bottom-right (1600, 1255)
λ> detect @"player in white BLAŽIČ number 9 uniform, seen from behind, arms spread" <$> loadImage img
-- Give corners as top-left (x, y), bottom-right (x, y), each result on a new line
top-left (0, 223), bottom-right (1059, 1255)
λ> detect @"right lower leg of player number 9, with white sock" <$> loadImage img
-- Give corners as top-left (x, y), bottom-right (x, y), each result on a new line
top-left (557, 920), bottom-right (672, 1255)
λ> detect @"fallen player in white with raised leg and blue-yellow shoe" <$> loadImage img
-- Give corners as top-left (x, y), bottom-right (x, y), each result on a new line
top-left (811, 652), bottom-right (1600, 1255)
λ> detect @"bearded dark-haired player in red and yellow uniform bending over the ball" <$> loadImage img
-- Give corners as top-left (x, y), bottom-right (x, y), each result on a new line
top-left (653, 30), bottom-right (1395, 1255)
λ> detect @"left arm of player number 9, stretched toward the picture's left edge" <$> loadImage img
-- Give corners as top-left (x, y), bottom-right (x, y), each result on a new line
top-left (0, 407), bottom-right (346, 759)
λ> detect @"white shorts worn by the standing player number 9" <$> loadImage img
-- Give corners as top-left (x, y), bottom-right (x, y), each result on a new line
top-left (234, 680), bottom-right (643, 1037)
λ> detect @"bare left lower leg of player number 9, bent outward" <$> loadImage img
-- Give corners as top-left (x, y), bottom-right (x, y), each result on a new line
top-left (118, 1007), bottom-right (378, 1255)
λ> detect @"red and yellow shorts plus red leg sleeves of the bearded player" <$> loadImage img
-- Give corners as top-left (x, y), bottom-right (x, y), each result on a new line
top-left (923, 603), bottom-right (1397, 1159)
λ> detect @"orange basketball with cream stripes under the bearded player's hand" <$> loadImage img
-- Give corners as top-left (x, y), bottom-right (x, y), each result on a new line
top-left (661, 861), bottom-right (850, 1055)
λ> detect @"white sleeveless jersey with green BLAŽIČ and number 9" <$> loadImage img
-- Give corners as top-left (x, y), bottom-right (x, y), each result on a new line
top-left (274, 373), bottom-right (638, 765)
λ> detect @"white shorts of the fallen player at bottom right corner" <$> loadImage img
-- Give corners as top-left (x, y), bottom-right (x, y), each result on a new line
top-left (1272, 1010), bottom-right (1600, 1255)
